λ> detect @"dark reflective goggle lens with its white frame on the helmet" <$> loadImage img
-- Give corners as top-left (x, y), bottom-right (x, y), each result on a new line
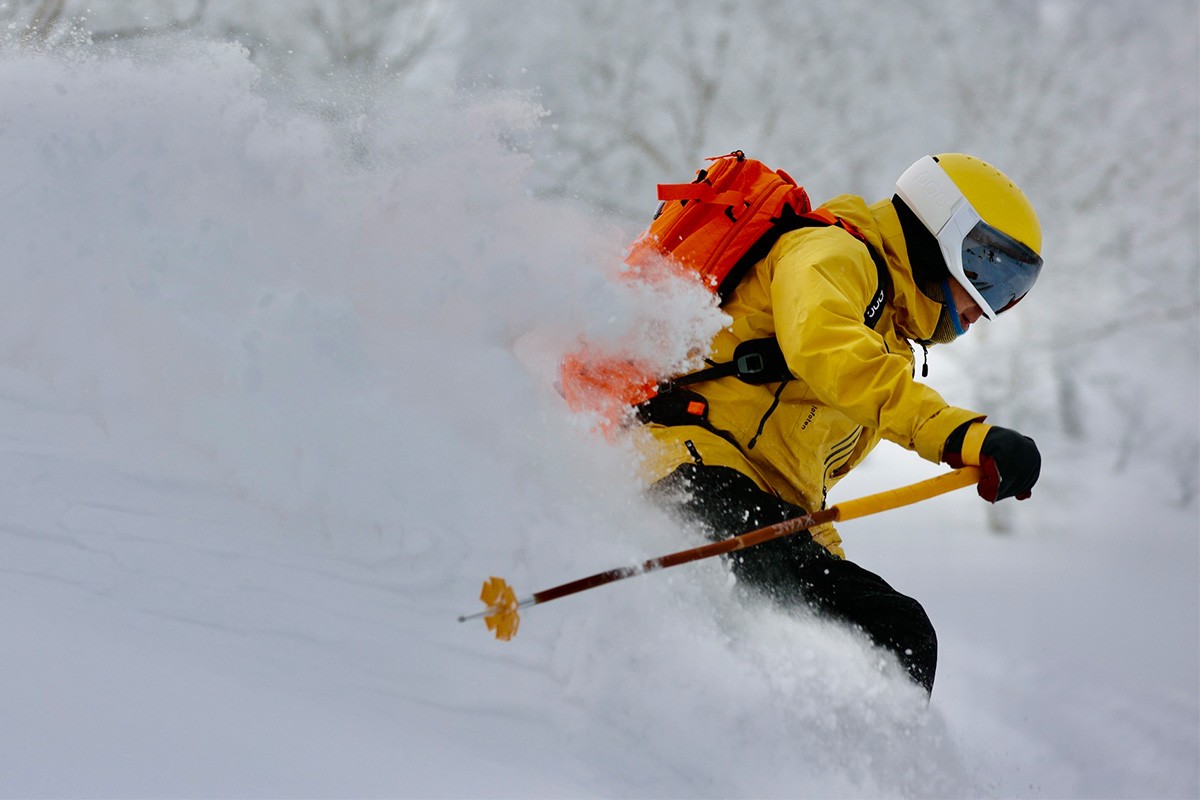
top-left (937, 198), bottom-right (1042, 319)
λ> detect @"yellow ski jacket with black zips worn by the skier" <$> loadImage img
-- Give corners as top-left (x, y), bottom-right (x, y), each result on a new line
top-left (642, 196), bottom-right (984, 557)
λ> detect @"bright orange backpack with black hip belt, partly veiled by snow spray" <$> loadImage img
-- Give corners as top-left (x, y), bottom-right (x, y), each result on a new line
top-left (560, 150), bottom-right (884, 425)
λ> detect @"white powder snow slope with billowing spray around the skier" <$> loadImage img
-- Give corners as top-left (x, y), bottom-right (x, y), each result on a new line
top-left (0, 46), bottom-right (1200, 796)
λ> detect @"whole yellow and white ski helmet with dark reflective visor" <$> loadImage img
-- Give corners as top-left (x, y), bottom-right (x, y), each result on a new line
top-left (896, 152), bottom-right (1042, 319)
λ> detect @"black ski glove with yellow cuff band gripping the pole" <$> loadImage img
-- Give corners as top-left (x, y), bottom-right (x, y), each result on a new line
top-left (942, 422), bottom-right (1042, 503)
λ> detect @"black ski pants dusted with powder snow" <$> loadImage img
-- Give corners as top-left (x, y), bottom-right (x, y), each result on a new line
top-left (650, 464), bottom-right (937, 692)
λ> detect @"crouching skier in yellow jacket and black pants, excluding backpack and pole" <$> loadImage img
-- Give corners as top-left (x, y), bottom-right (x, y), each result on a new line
top-left (642, 154), bottom-right (1042, 692)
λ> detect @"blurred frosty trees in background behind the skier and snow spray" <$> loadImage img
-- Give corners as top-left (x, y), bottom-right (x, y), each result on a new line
top-left (0, 0), bottom-right (1200, 510)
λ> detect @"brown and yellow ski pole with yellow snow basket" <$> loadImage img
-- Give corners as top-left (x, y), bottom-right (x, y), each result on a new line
top-left (458, 467), bottom-right (980, 640)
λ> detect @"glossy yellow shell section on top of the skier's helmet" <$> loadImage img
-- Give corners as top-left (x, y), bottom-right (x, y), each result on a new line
top-left (934, 152), bottom-right (1042, 255)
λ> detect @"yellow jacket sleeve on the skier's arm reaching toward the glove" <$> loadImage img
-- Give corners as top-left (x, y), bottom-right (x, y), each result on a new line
top-left (770, 228), bottom-right (983, 463)
